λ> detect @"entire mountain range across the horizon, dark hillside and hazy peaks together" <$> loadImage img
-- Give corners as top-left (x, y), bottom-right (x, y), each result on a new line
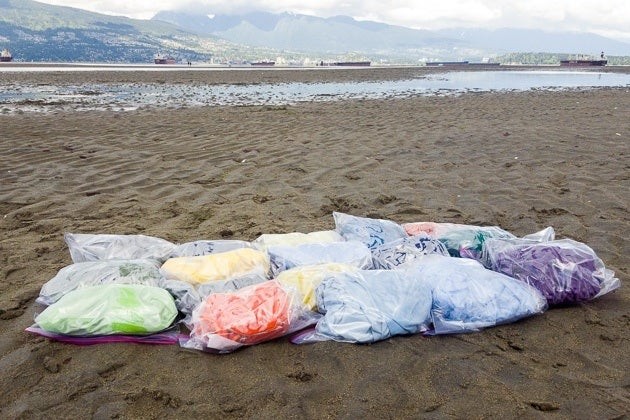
top-left (0, 0), bottom-right (630, 64)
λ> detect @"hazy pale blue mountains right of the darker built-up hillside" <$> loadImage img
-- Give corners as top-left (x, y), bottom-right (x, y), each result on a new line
top-left (153, 11), bottom-right (630, 59)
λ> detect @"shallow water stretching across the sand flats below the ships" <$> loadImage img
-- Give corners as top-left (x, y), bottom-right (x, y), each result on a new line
top-left (0, 66), bottom-right (630, 114)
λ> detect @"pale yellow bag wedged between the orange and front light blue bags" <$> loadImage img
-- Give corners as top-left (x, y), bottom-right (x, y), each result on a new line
top-left (276, 264), bottom-right (363, 311)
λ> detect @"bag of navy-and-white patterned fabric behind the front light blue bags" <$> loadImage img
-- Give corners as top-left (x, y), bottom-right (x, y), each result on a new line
top-left (372, 234), bottom-right (449, 270)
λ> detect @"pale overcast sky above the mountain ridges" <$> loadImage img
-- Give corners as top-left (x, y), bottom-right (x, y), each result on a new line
top-left (38, 0), bottom-right (630, 42)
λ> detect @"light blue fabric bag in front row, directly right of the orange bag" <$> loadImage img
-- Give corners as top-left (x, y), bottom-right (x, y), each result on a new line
top-left (292, 270), bottom-right (431, 344)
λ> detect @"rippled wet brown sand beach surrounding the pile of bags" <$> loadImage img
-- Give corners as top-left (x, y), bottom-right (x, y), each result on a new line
top-left (0, 69), bottom-right (630, 419)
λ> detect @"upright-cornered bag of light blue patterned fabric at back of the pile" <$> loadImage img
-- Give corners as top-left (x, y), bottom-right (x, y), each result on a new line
top-left (333, 212), bottom-right (408, 249)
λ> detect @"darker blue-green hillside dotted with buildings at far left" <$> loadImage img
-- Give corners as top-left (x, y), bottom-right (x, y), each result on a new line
top-left (0, 0), bottom-right (226, 63)
